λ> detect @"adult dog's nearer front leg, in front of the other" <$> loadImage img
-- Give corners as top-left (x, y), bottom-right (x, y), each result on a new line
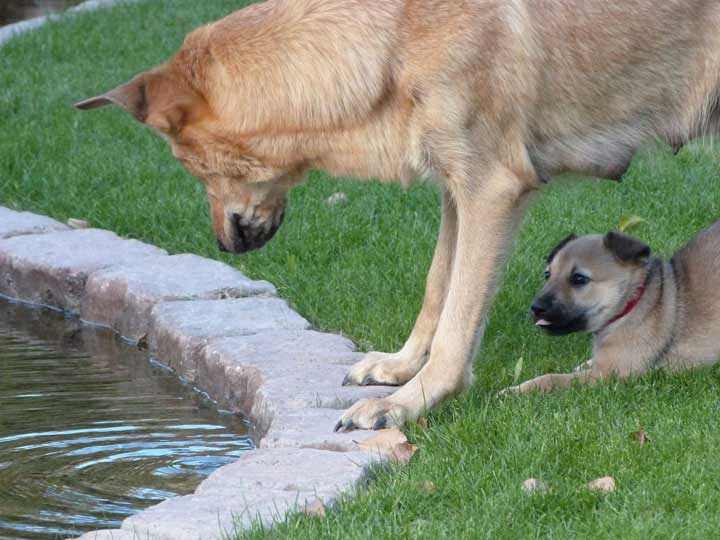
top-left (336, 165), bottom-right (532, 429)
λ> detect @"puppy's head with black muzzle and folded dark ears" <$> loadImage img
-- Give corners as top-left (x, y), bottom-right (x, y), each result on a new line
top-left (530, 232), bottom-right (650, 335)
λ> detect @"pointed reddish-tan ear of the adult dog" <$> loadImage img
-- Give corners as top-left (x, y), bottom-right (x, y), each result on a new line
top-left (75, 71), bottom-right (207, 134)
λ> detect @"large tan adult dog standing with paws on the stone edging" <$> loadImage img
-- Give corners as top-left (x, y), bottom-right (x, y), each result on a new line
top-left (78, 0), bottom-right (720, 429)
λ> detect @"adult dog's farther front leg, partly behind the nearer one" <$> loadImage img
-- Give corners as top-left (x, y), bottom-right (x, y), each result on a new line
top-left (343, 189), bottom-right (457, 385)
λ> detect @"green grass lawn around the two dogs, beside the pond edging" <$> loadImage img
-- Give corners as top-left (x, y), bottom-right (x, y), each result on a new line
top-left (0, 0), bottom-right (720, 540)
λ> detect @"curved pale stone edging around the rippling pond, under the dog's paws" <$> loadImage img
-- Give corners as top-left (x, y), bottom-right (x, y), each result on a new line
top-left (0, 207), bottom-right (388, 540)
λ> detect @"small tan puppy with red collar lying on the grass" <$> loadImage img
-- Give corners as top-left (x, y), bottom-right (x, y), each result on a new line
top-left (506, 222), bottom-right (720, 393)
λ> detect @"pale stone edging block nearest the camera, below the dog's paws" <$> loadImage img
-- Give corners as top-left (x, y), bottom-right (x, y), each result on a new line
top-left (122, 448), bottom-right (372, 540)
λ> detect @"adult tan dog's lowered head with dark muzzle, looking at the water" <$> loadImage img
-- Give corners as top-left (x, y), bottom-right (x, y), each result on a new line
top-left (76, 50), bottom-right (304, 253)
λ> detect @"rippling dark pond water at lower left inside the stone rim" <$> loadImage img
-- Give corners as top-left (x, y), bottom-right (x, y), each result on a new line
top-left (0, 300), bottom-right (252, 540)
